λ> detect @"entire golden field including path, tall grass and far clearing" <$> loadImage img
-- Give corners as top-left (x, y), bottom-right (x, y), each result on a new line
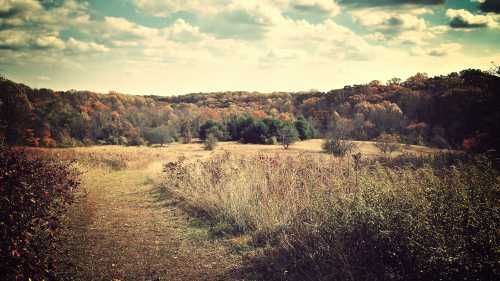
top-left (29, 140), bottom-right (499, 280)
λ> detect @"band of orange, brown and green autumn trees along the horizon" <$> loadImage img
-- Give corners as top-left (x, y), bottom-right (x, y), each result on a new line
top-left (0, 69), bottom-right (500, 150)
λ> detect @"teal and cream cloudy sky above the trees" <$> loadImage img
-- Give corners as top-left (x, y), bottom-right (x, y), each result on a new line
top-left (0, 0), bottom-right (500, 95)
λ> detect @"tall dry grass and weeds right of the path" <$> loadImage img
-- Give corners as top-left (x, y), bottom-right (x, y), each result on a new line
top-left (165, 153), bottom-right (500, 280)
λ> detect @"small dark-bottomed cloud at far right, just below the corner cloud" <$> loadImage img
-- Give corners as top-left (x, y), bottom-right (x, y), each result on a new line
top-left (446, 9), bottom-right (498, 28)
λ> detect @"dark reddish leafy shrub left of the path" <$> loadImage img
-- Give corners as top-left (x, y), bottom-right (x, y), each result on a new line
top-left (0, 148), bottom-right (79, 280)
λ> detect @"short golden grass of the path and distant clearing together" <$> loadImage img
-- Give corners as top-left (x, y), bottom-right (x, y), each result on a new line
top-left (39, 139), bottom-right (456, 280)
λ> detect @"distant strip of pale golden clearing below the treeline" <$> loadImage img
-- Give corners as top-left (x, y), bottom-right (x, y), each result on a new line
top-left (28, 139), bottom-right (450, 169)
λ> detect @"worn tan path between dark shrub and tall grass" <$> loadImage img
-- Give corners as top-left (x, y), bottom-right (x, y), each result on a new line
top-left (64, 162), bottom-right (241, 281)
